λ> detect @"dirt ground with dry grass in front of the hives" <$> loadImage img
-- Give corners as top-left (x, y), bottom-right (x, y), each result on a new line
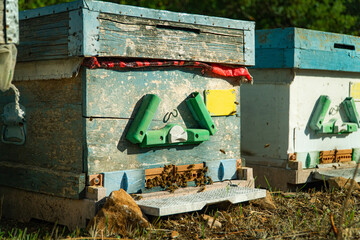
top-left (0, 186), bottom-right (360, 239)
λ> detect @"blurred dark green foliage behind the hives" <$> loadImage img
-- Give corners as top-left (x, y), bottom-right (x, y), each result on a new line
top-left (19, 0), bottom-right (360, 35)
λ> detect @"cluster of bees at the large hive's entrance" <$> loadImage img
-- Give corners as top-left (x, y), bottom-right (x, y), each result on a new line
top-left (146, 164), bottom-right (213, 193)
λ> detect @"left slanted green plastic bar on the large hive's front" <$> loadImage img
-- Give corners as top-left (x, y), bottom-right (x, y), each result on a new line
top-left (126, 94), bottom-right (161, 143)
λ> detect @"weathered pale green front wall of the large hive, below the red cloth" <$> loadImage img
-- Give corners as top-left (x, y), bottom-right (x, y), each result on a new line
top-left (83, 68), bottom-right (240, 174)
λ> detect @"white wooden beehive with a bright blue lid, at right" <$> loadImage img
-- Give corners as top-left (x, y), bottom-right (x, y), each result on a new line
top-left (241, 28), bottom-right (360, 189)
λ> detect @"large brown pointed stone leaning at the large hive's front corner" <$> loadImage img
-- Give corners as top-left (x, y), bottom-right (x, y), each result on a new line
top-left (88, 189), bottom-right (150, 236)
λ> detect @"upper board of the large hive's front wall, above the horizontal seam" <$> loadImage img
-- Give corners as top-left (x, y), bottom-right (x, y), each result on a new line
top-left (83, 68), bottom-right (239, 118)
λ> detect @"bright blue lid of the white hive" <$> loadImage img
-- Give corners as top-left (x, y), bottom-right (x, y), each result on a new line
top-left (255, 28), bottom-right (360, 72)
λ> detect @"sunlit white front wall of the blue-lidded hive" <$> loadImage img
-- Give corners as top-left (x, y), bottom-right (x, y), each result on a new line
top-left (288, 70), bottom-right (360, 152)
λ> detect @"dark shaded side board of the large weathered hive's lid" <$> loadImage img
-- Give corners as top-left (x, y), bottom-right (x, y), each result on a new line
top-left (18, 12), bottom-right (70, 62)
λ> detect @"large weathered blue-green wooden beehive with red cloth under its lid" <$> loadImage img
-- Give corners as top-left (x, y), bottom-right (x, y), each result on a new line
top-left (0, 0), bottom-right (254, 199)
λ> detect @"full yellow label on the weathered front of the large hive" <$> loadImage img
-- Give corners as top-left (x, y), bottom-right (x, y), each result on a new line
top-left (205, 89), bottom-right (239, 116)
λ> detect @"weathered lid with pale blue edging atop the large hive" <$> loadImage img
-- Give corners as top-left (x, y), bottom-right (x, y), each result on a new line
top-left (18, 0), bottom-right (255, 66)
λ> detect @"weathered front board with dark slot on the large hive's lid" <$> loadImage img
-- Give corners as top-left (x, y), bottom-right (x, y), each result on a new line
top-left (99, 13), bottom-right (245, 64)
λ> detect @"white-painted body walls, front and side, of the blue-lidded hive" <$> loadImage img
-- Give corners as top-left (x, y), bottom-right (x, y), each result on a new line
top-left (241, 69), bottom-right (360, 160)
